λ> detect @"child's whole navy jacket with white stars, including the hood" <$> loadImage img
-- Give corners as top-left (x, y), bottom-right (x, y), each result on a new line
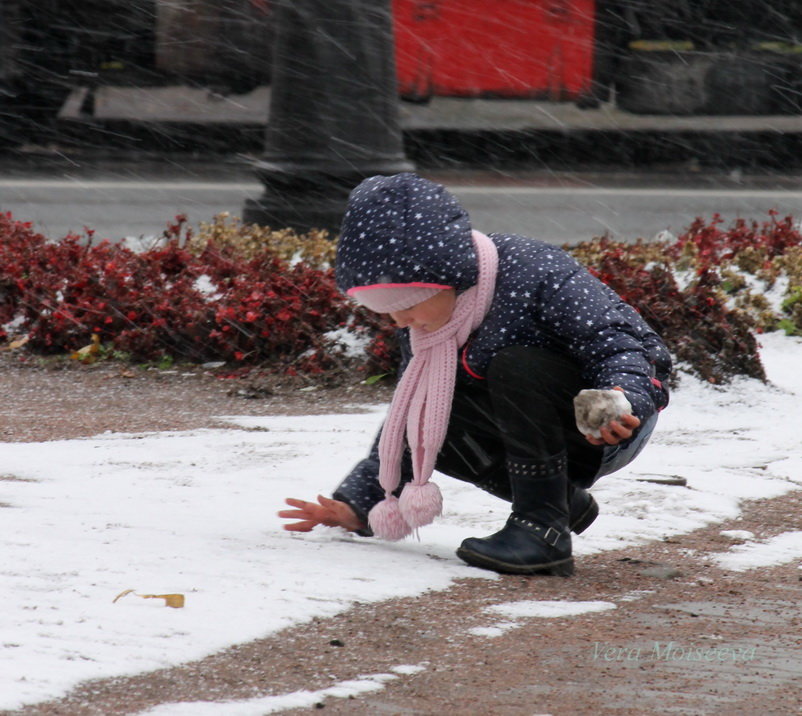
top-left (334, 174), bottom-right (671, 518)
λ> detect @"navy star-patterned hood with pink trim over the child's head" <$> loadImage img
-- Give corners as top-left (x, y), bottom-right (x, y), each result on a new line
top-left (336, 173), bottom-right (478, 293)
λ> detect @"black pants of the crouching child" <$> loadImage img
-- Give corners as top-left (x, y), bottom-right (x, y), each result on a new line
top-left (436, 346), bottom-right (604, 492)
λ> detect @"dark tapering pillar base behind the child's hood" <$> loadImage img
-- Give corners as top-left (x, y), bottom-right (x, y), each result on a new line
top-left (243, 0), bottom-right (412, 231)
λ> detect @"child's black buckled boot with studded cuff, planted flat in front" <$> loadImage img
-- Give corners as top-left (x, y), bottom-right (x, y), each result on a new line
top-left (457, 452), bottom-right (572, 577)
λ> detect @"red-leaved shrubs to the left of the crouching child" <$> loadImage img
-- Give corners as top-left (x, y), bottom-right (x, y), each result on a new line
top-left (0, 214), bottom-right (391, 373)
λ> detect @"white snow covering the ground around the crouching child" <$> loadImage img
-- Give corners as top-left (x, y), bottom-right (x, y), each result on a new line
top-left (0, 335), bottom-right (802, 715)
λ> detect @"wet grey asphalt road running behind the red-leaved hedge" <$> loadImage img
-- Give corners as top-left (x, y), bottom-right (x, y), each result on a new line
top-left (0, 160), bottom-right (802, 244)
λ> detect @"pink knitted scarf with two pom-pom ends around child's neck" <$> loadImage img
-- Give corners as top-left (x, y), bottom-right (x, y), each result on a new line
top-left (368, 231), bottom-right (498, 540)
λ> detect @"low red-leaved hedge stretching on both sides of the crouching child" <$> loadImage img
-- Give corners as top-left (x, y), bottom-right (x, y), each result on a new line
top-left (0, 212), bottom-right (802, 383)
